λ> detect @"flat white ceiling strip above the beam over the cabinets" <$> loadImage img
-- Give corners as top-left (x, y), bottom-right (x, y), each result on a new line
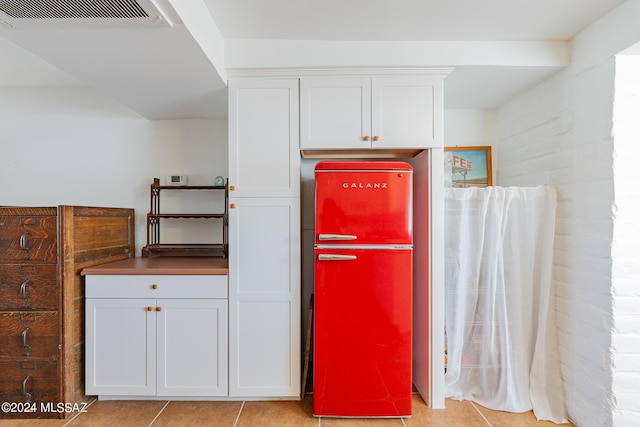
top-left (205, 0), bottom-right (623, 41)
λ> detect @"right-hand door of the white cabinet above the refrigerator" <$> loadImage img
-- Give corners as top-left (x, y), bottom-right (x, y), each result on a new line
top-left (371, 76), bottom-right (443, 148)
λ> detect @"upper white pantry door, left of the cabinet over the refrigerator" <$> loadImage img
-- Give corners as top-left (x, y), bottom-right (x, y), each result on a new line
top-left (229, 79), bottom-right (300, 197)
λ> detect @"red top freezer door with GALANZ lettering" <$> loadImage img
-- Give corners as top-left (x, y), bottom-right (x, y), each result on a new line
top-left (315, 162), bottom-right (413, 245)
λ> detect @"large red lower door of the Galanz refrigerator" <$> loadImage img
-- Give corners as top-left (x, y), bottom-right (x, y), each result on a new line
top-left (313, 249), bottom-right (412, 417)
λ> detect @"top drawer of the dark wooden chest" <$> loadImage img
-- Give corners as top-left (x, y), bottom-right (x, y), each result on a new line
top-left (0, 215), bottom-right (57, 262)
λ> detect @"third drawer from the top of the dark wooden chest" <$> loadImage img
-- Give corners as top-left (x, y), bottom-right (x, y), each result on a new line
top-left (0, 311), bottom-right (58, 359)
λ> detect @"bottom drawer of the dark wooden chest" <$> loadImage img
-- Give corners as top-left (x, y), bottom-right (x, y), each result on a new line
top-left (0, 360), bottom-right (61, 419)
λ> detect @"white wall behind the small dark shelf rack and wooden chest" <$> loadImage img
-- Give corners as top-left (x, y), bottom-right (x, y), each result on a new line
top-left (0, 86), bottom-right (228, 256)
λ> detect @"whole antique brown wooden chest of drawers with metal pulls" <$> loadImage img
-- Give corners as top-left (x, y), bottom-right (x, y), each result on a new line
top-left (0, 206), bottom-right (135, 418)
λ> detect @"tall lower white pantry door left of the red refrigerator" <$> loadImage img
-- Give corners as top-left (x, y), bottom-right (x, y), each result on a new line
top-left (229, 198), bottom-right (300, 397)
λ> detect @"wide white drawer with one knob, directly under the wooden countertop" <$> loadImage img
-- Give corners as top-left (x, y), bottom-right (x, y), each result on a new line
top-left (85, 275), bottom-right (227, 298)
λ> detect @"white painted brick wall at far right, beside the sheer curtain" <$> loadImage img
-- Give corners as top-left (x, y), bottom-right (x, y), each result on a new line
top-left (497, 1), bottom-right (640, 427)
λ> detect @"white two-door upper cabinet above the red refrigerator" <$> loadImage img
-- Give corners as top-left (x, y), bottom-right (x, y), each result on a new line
top-left (300, 76), bottom-right (443, 150)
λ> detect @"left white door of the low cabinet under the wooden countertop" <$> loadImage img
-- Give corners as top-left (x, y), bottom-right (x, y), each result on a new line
top-left (85, 299), bottom-right (156, 396)
